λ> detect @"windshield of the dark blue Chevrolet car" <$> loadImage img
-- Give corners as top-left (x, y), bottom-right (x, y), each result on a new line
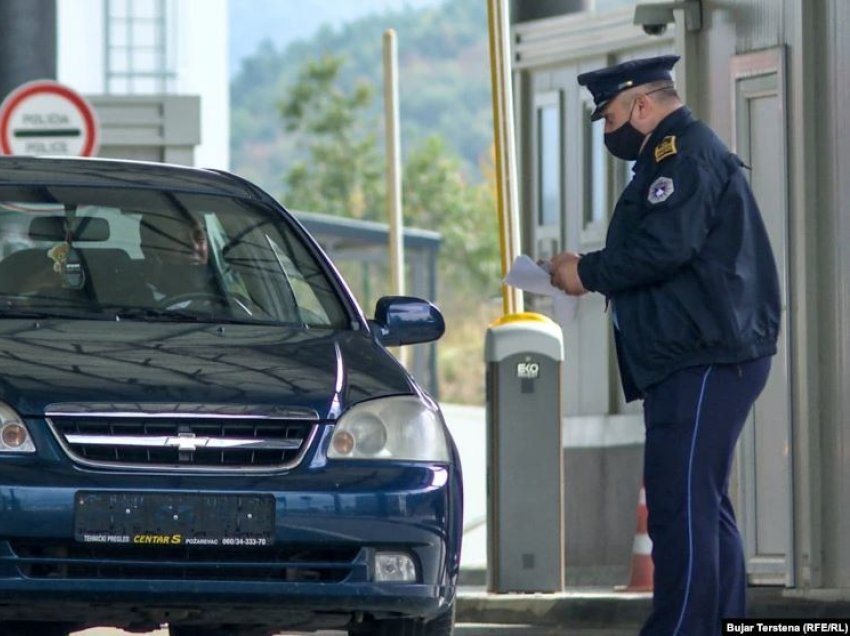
top-left (0, 181), bottom-right (351, 328)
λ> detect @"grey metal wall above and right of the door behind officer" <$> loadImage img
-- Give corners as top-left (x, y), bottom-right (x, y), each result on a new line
top-left (704, 0), bottom-right (850, 597)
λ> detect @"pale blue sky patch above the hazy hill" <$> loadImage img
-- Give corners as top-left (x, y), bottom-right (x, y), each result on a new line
top-left (229, 0), bottom-right (445, 75)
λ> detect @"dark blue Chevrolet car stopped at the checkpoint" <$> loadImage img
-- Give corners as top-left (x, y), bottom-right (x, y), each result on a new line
top-left (0, 157), bottom-right (462, 636)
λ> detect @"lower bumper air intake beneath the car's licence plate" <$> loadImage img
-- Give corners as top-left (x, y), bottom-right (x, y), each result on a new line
top-left (9, 540), bottom-right (366, 582)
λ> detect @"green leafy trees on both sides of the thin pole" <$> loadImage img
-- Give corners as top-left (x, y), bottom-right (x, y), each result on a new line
top-left (280, 54), bottom-right (498, 295)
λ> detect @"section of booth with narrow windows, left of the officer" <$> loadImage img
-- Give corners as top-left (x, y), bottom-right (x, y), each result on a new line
top-left (511, 0), bottom-right (675, 587)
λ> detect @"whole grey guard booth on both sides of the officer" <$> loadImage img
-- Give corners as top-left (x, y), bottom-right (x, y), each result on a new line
top-left (512, 0), bottom-right (812, 589)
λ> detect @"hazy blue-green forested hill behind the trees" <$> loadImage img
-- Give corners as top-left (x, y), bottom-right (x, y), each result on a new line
top-left (231, 0), bottom-right (493, 195)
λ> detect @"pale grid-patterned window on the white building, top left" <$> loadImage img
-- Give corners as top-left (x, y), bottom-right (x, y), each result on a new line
top-left (104, 0), bottom-right (177, 95)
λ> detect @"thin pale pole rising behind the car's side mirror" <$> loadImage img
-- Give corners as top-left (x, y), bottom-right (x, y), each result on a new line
top-left (384, 29), bottom-right (407, 366)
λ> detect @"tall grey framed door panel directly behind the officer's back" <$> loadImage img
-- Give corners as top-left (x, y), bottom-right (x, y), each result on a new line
top-left (731, 47), bottom-right (793, 585)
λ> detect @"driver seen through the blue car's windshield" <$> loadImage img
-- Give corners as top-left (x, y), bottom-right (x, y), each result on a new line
top-left (139, 213), bottom-right (220, 308)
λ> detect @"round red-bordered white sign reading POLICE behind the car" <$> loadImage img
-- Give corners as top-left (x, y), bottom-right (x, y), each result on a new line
top-left (0, 80), bottom-right (99, 157)
